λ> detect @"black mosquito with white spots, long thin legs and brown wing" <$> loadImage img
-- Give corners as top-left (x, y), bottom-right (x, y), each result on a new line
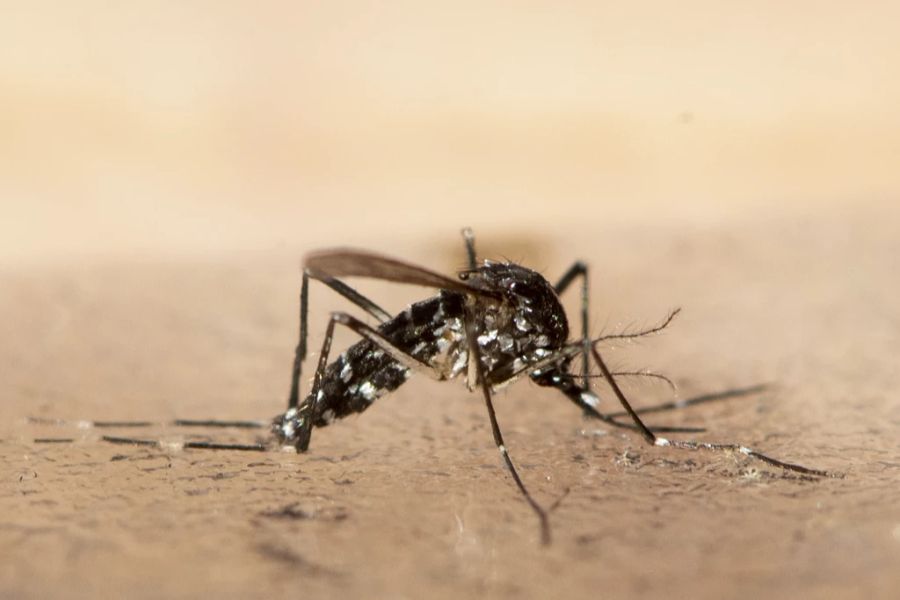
top-left (31, 228), bottom-right (830, 544)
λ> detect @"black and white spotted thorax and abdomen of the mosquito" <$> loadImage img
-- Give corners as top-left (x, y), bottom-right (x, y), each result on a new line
top-left (273, 261), bottom-right (568, 444)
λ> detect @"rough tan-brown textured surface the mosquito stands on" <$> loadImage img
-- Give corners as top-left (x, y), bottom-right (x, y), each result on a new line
top-left (0, 210), bottom-right (900, 598)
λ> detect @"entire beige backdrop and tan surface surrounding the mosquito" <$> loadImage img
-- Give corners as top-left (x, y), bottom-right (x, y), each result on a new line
top-left (0, 1), bottom-right (900, 598)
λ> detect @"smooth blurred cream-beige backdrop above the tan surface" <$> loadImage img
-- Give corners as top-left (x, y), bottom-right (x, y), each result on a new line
top-left (0, 0), bottom-right (900, 267)
